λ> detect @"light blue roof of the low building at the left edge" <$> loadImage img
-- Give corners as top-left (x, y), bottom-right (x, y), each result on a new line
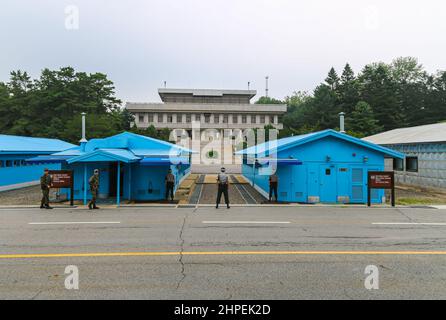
top-left (0, 134), bottom-right (75, 153)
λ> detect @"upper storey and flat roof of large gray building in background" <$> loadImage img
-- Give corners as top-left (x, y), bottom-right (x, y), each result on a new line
top-left (126, 88), bottom-right (287, 133)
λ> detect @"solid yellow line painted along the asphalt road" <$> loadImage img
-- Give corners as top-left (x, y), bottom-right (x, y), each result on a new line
top-left (0, 251), bottom-right (446, 259)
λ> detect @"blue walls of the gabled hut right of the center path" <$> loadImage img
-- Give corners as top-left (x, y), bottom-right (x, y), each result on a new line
top-left (242, 137), bottom-right (384, 203)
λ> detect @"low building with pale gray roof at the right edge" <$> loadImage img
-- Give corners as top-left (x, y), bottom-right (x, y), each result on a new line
top-left (364, 122), bottom-right (446, 189)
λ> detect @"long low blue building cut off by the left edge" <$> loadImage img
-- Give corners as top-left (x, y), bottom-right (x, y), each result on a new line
top-left (0, 134), bottom-right (75, 191)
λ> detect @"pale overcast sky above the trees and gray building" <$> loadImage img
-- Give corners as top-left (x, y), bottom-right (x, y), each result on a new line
top-left (0, 0), bottom-right (446, 102)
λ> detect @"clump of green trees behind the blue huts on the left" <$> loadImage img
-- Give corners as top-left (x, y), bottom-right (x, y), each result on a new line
top-left (0, 67), bottom-right (133, 143)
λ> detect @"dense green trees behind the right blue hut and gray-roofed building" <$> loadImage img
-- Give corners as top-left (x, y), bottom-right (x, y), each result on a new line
top-left (257, 57), bottom-right (446, 137)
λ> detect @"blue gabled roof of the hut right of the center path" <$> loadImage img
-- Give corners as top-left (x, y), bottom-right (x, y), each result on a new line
top-left (235, 129), bottom-right (404, 159)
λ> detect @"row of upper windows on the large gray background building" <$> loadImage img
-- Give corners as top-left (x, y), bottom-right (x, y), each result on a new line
top-left (136, 113), bottom-right (278, 124)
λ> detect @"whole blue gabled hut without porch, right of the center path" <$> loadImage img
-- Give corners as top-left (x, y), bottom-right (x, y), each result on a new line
top-left (236, 130), bottom-right (404, 203)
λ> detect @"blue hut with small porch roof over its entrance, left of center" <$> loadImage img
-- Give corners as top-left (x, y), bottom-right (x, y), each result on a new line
top-left (31, 132), bottom-right (192, 204)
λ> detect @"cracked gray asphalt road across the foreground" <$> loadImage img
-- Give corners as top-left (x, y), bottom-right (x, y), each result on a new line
top-left (0, 206), bottom-right (446, 299)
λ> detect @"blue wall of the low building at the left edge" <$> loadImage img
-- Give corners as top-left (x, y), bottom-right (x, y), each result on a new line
top-left (0, 154), bottom-right (60, 187)
